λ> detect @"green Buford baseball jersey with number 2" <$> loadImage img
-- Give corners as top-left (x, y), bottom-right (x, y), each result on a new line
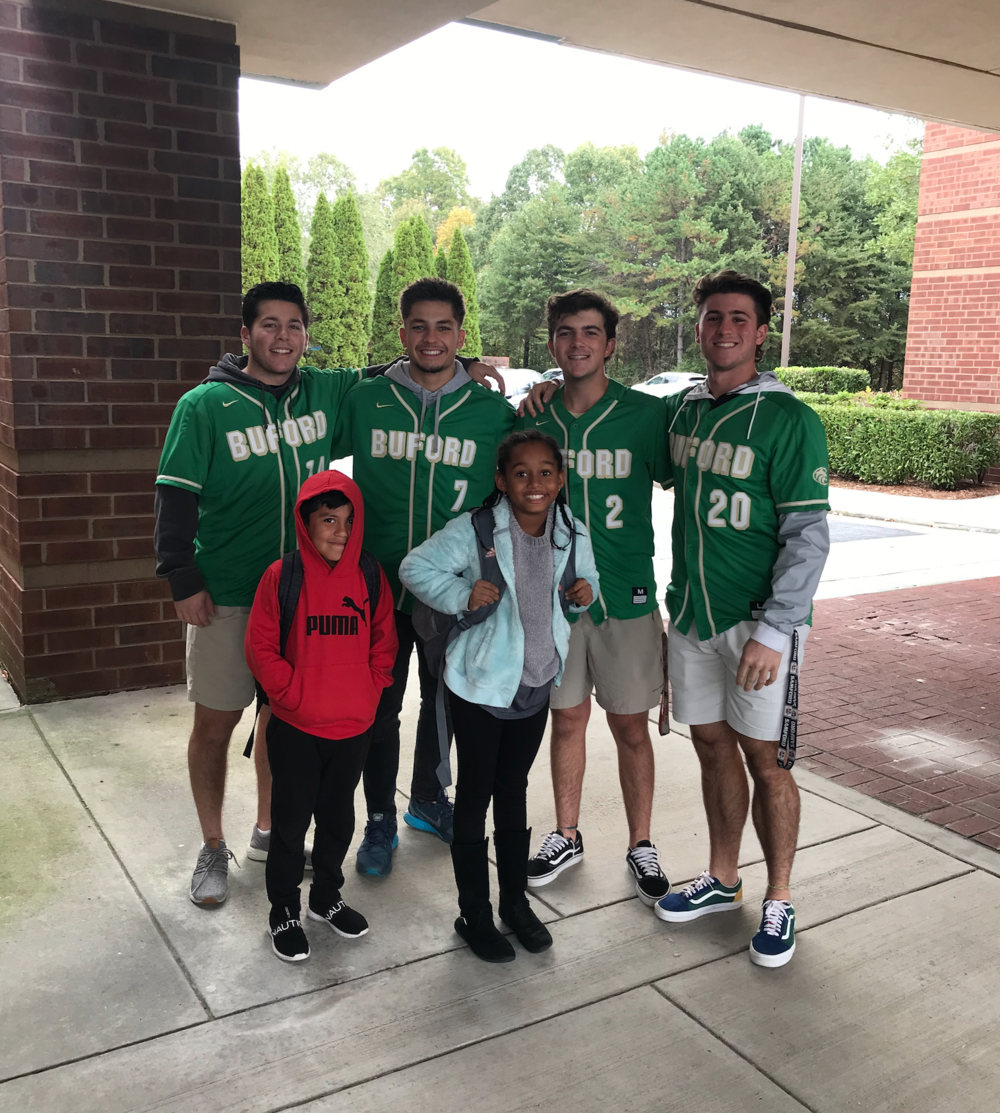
top-left (518, 380), bottom-right (670, 624)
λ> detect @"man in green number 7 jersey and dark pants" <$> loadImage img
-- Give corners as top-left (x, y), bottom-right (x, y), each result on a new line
top-left (331, 278), bottom-right (514, 877)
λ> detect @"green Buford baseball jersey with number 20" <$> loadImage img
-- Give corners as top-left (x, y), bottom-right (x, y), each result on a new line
top-left (666, 387), bottom-right (830, 641)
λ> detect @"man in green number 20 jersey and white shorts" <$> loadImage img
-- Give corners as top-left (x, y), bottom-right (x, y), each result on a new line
top-left (655, 270), bottom-right (830, 966)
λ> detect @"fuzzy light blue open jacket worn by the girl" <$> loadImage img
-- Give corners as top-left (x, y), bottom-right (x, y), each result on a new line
top-left (400, 499), bottom-right (599, 707)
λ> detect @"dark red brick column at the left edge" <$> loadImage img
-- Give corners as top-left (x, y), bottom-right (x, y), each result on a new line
top-left (0, 0), bottom-right (241, 701)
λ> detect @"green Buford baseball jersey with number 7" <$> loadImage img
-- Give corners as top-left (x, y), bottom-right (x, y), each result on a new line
top-left (332, 375), bottom-right (514, 614)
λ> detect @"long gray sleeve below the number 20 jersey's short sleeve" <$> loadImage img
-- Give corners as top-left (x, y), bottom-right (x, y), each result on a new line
top-left (753, 510), bottom-right (830, 652)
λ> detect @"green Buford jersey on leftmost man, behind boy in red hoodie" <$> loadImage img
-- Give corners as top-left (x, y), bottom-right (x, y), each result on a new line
top-left (156, 367), bottom-right (364, 607)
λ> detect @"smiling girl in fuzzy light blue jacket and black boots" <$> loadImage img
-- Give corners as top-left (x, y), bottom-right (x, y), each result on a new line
top-left (400, 430), bottom-right (598, 963)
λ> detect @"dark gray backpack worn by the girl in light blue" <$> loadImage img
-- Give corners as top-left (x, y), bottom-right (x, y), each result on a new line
top-left (413, 506), bottom-right (577, 788)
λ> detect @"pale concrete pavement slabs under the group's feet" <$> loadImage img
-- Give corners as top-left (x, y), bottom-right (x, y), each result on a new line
top-left (0, 684), bottom-right (1000, 1113)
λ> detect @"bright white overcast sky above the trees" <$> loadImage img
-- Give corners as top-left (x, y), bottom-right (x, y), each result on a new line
top-left (239, 23), bottom-right (923, 199)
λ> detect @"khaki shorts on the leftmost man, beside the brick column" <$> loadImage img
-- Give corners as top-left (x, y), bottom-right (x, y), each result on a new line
top-left (186, 607), bottom-right (255, 711)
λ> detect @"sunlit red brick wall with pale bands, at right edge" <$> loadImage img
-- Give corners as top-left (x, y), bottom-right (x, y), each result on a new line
top-left (903, 124), bottom-right (1000, 411)
